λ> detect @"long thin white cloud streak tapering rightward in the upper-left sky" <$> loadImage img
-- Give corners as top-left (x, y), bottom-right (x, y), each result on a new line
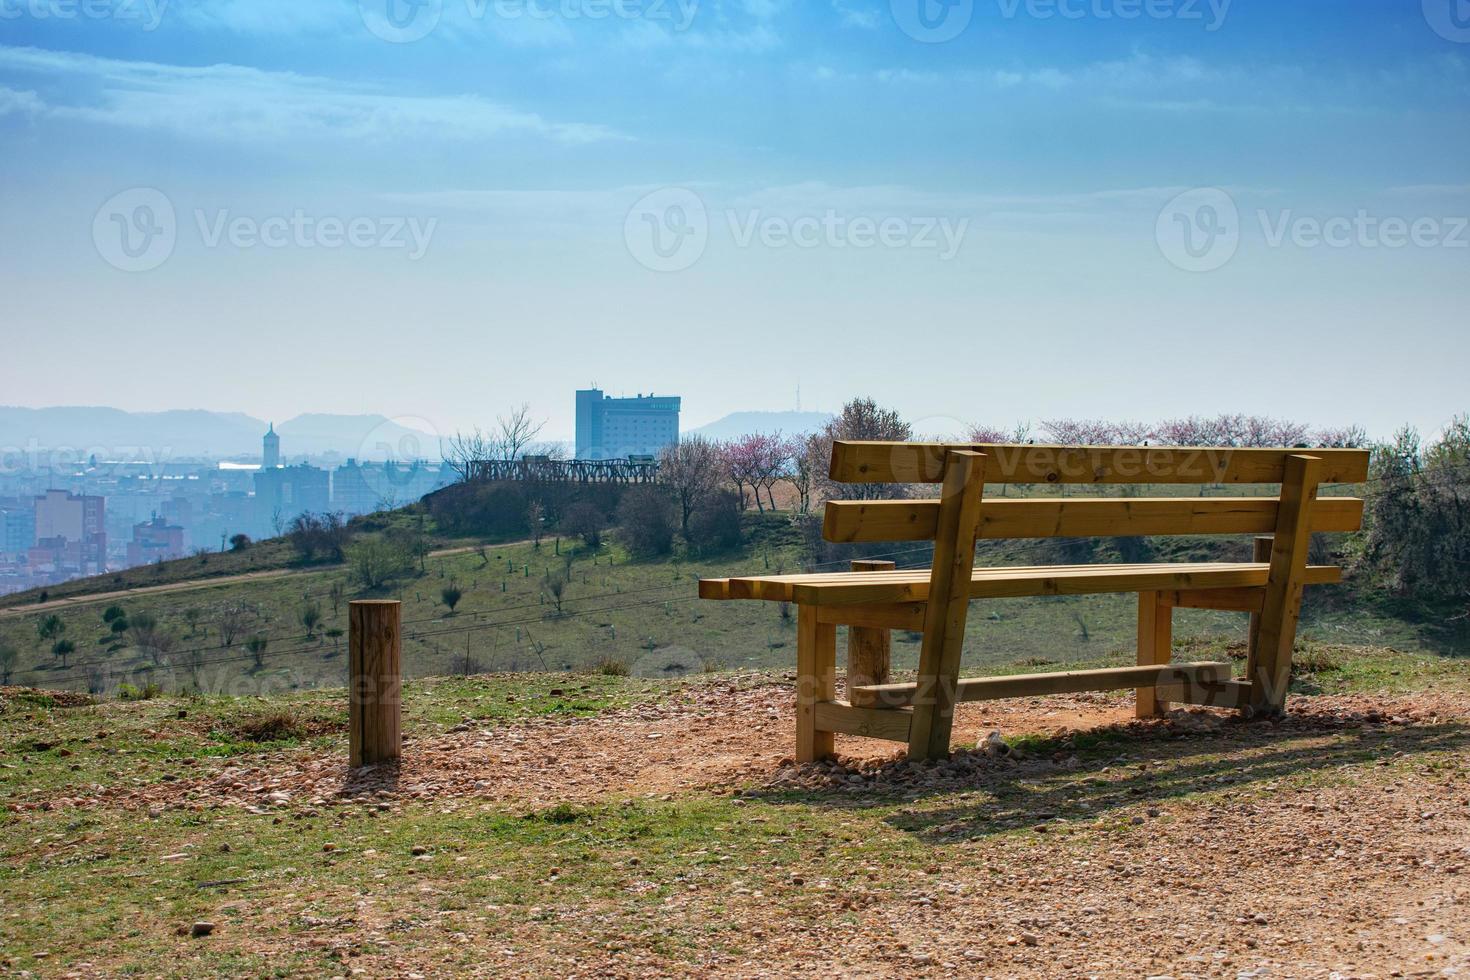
top-left (0, 47), bottom-right (625, 143)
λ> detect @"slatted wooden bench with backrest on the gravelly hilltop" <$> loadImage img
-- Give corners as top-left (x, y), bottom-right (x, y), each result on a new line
top-left (700, 442), bottom-right (1369, 761)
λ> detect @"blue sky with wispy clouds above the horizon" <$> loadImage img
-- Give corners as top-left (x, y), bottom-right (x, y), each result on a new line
top-left (0, 0), bottom-right (1470, 435)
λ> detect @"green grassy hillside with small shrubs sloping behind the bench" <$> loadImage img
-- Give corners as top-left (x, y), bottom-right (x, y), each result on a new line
top-left (0, 516), bottom-right (1433, 693)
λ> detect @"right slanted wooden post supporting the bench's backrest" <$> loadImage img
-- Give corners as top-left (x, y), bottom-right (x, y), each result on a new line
top-left (1251, 455), bottom-right (1322, 714)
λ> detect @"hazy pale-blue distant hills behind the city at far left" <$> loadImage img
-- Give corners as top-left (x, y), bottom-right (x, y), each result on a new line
top-left (0, 406), bottom-right (440, 463)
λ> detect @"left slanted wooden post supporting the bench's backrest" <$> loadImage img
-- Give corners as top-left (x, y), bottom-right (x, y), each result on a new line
top-left (908, 450), bottom-right (985, 761)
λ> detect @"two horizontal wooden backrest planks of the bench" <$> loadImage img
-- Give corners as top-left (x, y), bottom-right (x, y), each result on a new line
top-left (823, 441), bottom-right (1369, 542)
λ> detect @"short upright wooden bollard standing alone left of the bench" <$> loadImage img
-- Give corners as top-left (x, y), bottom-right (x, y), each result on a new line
top-left (347, 599), bottom-right (403, 768)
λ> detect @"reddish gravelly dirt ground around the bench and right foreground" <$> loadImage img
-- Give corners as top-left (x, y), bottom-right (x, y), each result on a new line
top-left (24, 685), bottom-right (1470, 980)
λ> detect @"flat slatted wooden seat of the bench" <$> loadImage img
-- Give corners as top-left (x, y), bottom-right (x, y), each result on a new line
top-left (700, 561), bottom-right (1342, 607)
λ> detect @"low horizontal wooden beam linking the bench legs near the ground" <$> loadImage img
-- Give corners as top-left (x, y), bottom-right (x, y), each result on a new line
top-left (854, 661), bottom-right (1230, 708)
